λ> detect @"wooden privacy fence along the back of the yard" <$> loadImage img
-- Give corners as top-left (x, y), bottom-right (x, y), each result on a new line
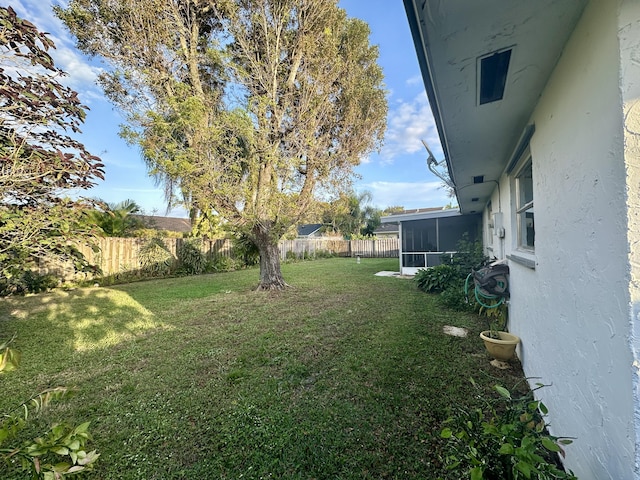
top-left (40, 237), bottom-right (398, 278)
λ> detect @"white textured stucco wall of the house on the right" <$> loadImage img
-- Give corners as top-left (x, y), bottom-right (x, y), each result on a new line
top-left (485, 0), bottom-right (640, 480)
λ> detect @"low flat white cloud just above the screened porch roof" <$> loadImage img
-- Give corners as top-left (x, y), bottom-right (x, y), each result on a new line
top-left (358, 182), bottom-right (455, 209)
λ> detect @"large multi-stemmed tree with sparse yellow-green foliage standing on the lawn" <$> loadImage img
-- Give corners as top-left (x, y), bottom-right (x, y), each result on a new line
top-left (57, 0), bottom-right (387, 289)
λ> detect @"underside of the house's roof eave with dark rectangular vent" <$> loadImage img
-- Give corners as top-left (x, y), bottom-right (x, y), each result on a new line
top-left (404, 0), bottom-right (588, 213)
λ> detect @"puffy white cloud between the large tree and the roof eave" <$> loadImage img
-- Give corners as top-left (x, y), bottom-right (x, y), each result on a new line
top-left (381, 91), bottom-right (442, 164)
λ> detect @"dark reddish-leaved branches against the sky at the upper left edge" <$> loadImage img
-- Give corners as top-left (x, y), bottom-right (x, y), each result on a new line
top-left (0, 7), bottom-right (104, 205)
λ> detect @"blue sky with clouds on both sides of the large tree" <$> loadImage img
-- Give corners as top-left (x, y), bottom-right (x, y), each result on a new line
top-left (8, 0), bottom-right (452, 216)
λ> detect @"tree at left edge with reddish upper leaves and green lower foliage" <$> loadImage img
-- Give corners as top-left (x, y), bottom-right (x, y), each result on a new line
top-left (0, 7), bottom-right (103, 288)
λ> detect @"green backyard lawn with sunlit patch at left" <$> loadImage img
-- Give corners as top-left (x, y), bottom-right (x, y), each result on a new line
top-left (0, 259), bottom-right (521, 479)
